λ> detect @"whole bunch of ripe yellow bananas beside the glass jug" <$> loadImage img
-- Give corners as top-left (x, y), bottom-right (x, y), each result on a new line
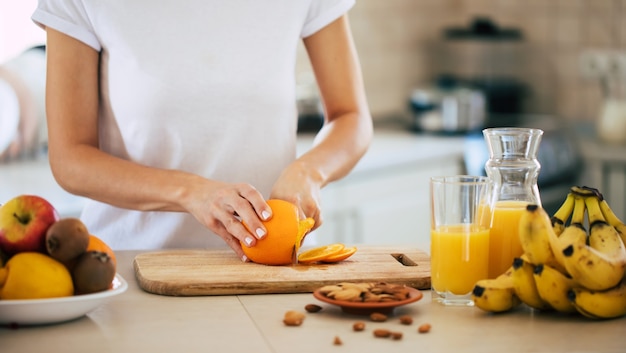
top-left (472, 186), bottom-right (626, 319)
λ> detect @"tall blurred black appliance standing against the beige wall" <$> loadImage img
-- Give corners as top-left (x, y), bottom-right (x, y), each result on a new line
top-left (432, 16), bottom-right (532, 127)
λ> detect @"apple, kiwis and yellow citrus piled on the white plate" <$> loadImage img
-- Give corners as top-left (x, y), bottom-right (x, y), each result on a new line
top-left (0, 195), bottom-right (117, 300)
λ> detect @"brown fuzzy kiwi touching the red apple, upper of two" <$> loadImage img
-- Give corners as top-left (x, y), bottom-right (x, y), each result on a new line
top-left (46, 218), bottom-right (89, 263)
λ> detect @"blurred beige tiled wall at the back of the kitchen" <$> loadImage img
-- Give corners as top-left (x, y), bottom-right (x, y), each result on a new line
top-left (294, 0), bottom-right (626, 122)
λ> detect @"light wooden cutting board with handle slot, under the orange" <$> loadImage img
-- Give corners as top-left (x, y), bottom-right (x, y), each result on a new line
top-left (133, 246), bottom-right (430, 296)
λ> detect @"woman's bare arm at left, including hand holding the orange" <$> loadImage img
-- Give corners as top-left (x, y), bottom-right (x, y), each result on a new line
top-left (46, 28), bottom-right (271, 256)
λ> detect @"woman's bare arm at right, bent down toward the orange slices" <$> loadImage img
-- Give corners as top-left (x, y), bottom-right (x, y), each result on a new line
top-left (272, 16), bottom-right (373, 226)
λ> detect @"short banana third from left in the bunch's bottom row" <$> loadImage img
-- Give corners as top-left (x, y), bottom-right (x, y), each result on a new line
top-left (533, 265), bottom-right (576, 313)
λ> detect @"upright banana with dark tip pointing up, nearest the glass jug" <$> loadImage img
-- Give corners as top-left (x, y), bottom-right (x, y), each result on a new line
top-left (519, 205), bottom-right (565, 271)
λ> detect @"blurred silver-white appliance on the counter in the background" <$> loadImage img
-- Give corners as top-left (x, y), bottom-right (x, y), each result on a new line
top-left (410, 76), bottom-right (486, 134)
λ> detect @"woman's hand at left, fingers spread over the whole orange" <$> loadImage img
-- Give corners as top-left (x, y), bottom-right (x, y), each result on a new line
top-left (187, 181), bottom-right (272, 261)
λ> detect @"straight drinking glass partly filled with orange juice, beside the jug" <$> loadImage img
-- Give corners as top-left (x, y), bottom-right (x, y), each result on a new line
top-left (430, 175), bottom-right (491, 306)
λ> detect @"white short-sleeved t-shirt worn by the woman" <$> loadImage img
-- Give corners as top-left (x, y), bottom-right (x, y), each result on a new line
top-left (32, 0), bottom-right (354, 249)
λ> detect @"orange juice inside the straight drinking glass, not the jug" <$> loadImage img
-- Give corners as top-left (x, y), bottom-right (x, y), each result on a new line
top-left (430, 224), bottom-right (489, 295)
